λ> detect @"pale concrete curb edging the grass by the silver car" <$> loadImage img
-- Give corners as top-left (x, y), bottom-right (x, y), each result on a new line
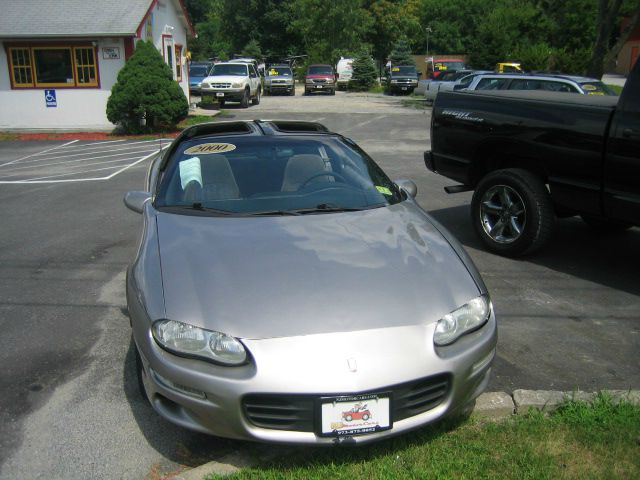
top-left (173, 390), bottom-right (640, 480)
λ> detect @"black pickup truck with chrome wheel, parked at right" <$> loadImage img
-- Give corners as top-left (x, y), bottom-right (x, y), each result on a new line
top-left (424, 62), bottom-right (640, 256)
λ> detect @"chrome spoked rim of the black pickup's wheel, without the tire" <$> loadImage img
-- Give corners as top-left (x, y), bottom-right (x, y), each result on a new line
top-left (480, 185), bottom-right (527, 244)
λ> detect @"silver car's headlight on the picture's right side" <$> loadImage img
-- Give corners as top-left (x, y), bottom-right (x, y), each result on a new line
top-left (433, 295), bottom-right (491, 347)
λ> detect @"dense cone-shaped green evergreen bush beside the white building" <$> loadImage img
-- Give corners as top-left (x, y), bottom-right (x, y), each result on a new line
top-left (107, 41), bottom-right (189, 133)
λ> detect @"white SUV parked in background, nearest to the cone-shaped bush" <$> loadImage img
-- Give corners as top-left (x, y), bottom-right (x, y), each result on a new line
top-left (200, 61), bottom-right (262, 108)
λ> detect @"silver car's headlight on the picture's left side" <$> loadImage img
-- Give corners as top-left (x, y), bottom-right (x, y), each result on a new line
top-left (151, 320), bottom-right (247, 365)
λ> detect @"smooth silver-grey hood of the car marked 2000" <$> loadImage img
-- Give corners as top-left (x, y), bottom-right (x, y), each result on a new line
top-left (157, 202), bottom-right (480, 339)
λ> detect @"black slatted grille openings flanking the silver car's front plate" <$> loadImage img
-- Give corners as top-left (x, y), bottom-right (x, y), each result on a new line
top-left (242, 374), bottom-right (451, 432)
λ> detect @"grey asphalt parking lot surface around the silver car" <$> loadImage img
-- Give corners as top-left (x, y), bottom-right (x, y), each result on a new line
top-left (0, 92), bottom-right (640, 479)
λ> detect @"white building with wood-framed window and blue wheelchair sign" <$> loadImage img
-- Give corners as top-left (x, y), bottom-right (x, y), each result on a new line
top-left (0, 0), bottom-right (195, 130)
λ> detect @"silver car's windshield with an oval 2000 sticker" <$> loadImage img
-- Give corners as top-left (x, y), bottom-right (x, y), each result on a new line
top-left (155, 136), bottom-right (402, 216)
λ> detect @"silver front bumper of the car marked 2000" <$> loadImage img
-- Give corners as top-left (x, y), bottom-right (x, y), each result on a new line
top-left (130, 300), bottom-right (497, 445)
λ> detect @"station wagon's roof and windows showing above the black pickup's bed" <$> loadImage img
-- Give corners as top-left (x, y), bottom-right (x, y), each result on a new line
top-left (465, 74), bottom-right (616, 95)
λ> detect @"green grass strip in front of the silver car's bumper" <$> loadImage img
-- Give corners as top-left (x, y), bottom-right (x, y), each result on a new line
top-left (207, 395), bottom-right (640, 480)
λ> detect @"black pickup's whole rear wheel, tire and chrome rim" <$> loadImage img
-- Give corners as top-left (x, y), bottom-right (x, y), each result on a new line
top-left (471, 168), bottom-right (555, 257)
